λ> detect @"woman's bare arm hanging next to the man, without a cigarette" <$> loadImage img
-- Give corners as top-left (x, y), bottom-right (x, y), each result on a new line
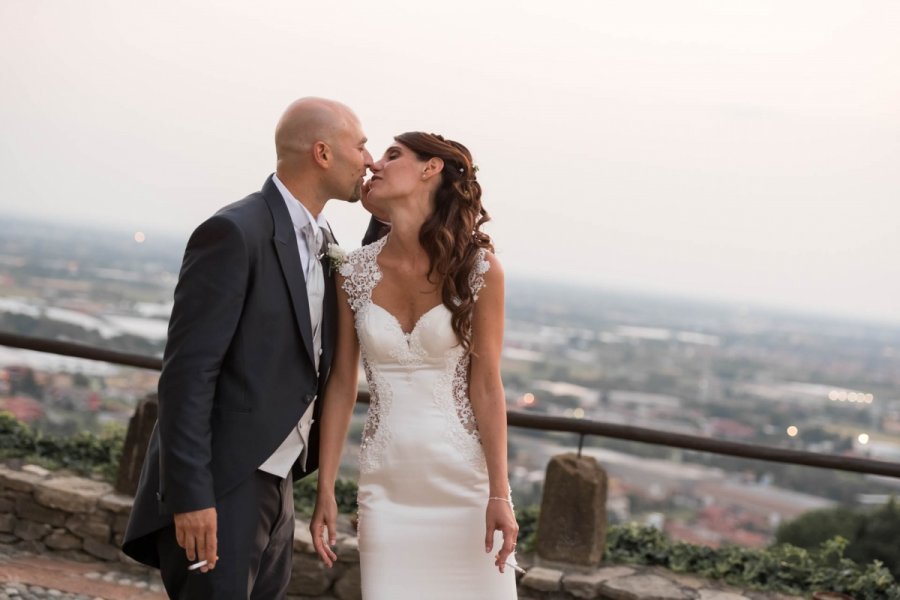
top-left (309, 275), bottom-right (359, 567)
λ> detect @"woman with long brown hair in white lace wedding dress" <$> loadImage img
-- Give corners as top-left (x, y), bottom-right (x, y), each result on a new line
top-left (310, 132), bottom-right (518, 600)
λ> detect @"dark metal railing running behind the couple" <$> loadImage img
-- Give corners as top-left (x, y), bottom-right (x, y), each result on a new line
top-left (0, 332), bottom-right (900, 478)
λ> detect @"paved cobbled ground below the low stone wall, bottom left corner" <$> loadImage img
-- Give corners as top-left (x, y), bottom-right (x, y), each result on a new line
top-left (0, 546), bottom-right (166, 600)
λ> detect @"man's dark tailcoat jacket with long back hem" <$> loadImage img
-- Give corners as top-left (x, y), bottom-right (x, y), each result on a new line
top-left (123, 177), bottom-right (337, 566)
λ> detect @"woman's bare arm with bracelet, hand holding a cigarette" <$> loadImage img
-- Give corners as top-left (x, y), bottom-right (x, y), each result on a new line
top-left (469, 253), bottom-right (519, 572)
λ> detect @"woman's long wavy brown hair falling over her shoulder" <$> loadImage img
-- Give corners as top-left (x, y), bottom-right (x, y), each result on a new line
top-left (394, 131), bottom-right (494, 352)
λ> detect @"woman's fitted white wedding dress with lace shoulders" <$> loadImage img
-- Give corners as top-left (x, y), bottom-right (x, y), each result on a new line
top-left (341, 237), bottom-right (516, 600)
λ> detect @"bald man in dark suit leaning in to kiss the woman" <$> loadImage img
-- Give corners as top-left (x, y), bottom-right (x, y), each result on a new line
top-left (123, 98), bottom-right (372, 600)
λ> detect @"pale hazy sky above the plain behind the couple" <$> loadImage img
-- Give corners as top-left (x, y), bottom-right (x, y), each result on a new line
top-left (0, 0), bottom-right (900, 320)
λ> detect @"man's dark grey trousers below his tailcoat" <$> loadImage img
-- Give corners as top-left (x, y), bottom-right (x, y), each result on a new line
top-left (157, 471), bottom-right (294, 600)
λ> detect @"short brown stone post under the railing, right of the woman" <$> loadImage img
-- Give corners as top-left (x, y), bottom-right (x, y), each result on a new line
top-left (536, 453), bottom-right (607, 566)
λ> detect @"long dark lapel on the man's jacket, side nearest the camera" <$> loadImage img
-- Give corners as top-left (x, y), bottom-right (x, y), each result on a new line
top-left (262, 177), bottom-right (318, 364)
